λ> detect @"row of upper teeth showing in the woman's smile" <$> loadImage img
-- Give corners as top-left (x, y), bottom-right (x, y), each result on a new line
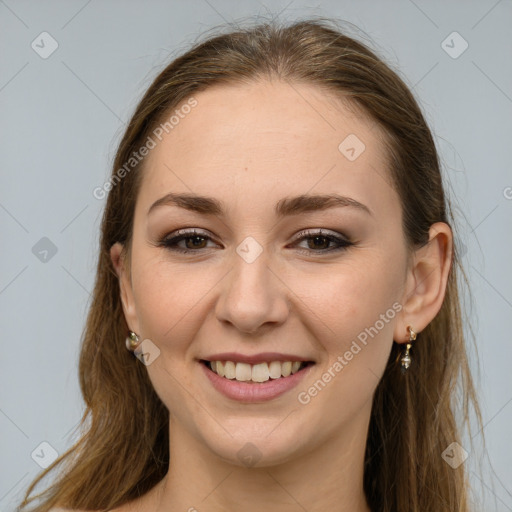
top-left (210, 361), bottom-right (306, 382)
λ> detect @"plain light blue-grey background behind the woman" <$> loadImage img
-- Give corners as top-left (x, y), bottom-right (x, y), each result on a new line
top-left (0, 0), bottom-right (512, 511)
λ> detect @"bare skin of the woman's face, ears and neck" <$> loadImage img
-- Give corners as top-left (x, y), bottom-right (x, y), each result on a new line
top-left (111, 81), bottom-right (452, 512)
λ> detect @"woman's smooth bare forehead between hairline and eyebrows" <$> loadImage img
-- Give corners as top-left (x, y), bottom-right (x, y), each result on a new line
top-left (138, 81), bottom-right (397, 218)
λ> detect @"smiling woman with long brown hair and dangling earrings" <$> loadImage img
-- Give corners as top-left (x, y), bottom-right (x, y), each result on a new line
top-left (18, 16), bottom-right (478, 512)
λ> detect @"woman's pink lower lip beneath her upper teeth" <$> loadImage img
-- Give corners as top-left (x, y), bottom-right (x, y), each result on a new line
top-left (199, 363), bottom-right (313, 402)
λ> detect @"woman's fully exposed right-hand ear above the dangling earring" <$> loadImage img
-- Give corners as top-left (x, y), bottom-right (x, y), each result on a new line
top-left (394, 222), bottom-right (453, 343)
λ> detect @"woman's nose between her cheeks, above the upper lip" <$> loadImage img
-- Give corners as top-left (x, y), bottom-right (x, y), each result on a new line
top-left (215, 254), bottom-right (289, 334)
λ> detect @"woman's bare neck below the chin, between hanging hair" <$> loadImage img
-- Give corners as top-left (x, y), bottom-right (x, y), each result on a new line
top-left (151, 411), bottom-right (370, 512)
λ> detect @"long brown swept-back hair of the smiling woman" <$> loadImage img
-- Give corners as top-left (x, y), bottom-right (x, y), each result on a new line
top-left (18, 19), bottom-right (481, 512)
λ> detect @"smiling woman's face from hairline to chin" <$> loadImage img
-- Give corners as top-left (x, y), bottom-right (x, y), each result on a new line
top-left (113, 82), bottom-right (407, 465)
